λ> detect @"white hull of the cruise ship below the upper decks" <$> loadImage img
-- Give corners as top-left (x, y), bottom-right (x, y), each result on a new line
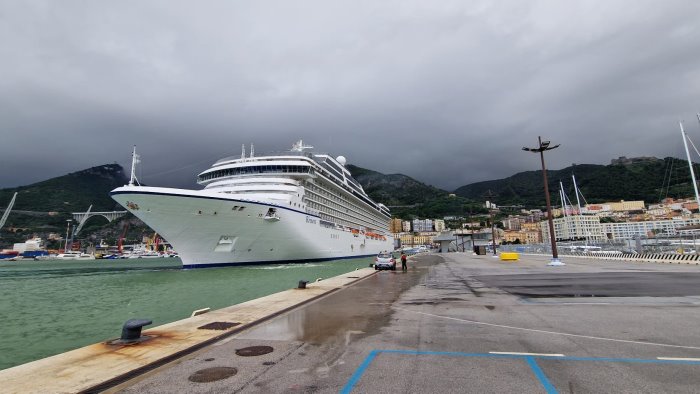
top-left (111, 186), bottom-right (393, 268)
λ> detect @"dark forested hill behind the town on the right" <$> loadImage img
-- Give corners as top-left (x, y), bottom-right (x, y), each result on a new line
top-left (455, 157), bottom-right (698, 207)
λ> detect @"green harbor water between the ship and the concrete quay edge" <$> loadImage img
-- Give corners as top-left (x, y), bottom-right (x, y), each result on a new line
top-left (0, 258), bottom-right (371, 369)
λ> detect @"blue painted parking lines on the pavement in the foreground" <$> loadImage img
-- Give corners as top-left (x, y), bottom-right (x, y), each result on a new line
top-left (340, 349), bottom-right (700, 394)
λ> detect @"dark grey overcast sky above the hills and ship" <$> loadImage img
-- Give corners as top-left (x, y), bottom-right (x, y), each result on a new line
top-left (0, 0), bottom-right (700, 190)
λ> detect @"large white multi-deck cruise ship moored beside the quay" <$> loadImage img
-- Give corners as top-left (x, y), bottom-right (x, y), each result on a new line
top-left (110, 141), bottom-right (393, 268)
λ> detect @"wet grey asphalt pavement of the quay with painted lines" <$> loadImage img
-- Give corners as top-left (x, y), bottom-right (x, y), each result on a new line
top-left (113, 254), bottom-right (700, 393)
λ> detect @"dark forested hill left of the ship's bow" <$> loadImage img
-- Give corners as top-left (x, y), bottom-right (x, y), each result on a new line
top-left (0, 164), bottom-right (128, 213)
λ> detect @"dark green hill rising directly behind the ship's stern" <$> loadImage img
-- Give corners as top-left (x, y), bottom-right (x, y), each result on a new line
top-left (346, 164), bottom-right (483, 219)
